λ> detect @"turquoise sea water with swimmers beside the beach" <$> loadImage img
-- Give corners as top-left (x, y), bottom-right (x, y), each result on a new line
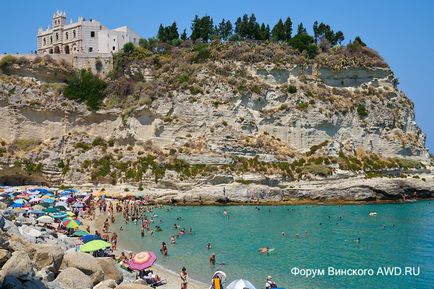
top-left (113, 202), bottom-right (434, 288)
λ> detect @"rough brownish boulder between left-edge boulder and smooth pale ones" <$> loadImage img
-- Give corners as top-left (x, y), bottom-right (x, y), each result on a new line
top-left (30, 244), bottom-right (63, 274)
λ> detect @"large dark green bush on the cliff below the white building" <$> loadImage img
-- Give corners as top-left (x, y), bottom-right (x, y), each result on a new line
top-left (64, 69), bottom-right (107, 111)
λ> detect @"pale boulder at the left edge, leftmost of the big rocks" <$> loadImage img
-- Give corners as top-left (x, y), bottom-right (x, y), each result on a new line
top-left (0, 251), bottom-right (35, 283)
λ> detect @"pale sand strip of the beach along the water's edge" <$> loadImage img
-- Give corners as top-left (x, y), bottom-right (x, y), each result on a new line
top-left (83, 206), bottom-right (209, 289)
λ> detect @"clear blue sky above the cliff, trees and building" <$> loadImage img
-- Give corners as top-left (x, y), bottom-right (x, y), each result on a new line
top-left (0, 0), bottom-right (434, 152)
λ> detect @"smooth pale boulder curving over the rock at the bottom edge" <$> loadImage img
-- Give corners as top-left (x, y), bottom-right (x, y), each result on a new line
top-left (61, 252), bottom-right (104, 285)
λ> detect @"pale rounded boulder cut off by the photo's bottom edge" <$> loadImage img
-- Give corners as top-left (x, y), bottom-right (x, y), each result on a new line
top-left (53, 267), bottom-right (93, 289)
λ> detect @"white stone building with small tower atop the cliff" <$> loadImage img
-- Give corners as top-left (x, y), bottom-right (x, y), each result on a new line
top-left (38, 11), bottom-right (140, 54)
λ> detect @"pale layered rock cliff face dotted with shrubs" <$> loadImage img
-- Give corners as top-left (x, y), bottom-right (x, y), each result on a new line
top-left (0, 42), bottom-right (429, 190)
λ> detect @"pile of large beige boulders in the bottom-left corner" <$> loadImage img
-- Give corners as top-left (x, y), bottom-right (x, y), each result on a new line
top-left (0, 220), bottom-right (125, 289)
